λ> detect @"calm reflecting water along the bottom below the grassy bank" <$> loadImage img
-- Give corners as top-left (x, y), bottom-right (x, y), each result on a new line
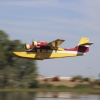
top-left (0, 92), bottom-right (100, 100)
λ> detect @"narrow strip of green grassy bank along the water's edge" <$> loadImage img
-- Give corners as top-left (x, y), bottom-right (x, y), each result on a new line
top-left (0, 88), bottom-right (100, 94)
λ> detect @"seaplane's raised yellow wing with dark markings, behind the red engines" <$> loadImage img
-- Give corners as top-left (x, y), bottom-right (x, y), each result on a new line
top-left (45, 39), bottom-right (65, 49)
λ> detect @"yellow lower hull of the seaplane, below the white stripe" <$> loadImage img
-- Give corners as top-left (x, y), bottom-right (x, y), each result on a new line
top-left (13, 50), bottom-right (77, 60)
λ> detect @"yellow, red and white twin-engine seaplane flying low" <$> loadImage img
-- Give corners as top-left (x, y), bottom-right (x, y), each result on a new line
top-left (13, 37), bottom-right (93, 60)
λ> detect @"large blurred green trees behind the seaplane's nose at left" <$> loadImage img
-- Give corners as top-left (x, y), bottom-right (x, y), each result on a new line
top-left (0, 30), bottom-right (37, 88)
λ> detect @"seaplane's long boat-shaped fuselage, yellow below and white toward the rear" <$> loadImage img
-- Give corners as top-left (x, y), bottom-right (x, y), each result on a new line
top-left (13, 49), bottom-right (84, 60)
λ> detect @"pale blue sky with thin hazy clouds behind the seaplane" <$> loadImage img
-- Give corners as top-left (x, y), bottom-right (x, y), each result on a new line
top-left (0, 0), bottom-right (100, 78)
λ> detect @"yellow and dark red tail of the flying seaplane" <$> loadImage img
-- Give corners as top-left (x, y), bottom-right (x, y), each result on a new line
top-left (77, 37), bottom-right (93, 54)
